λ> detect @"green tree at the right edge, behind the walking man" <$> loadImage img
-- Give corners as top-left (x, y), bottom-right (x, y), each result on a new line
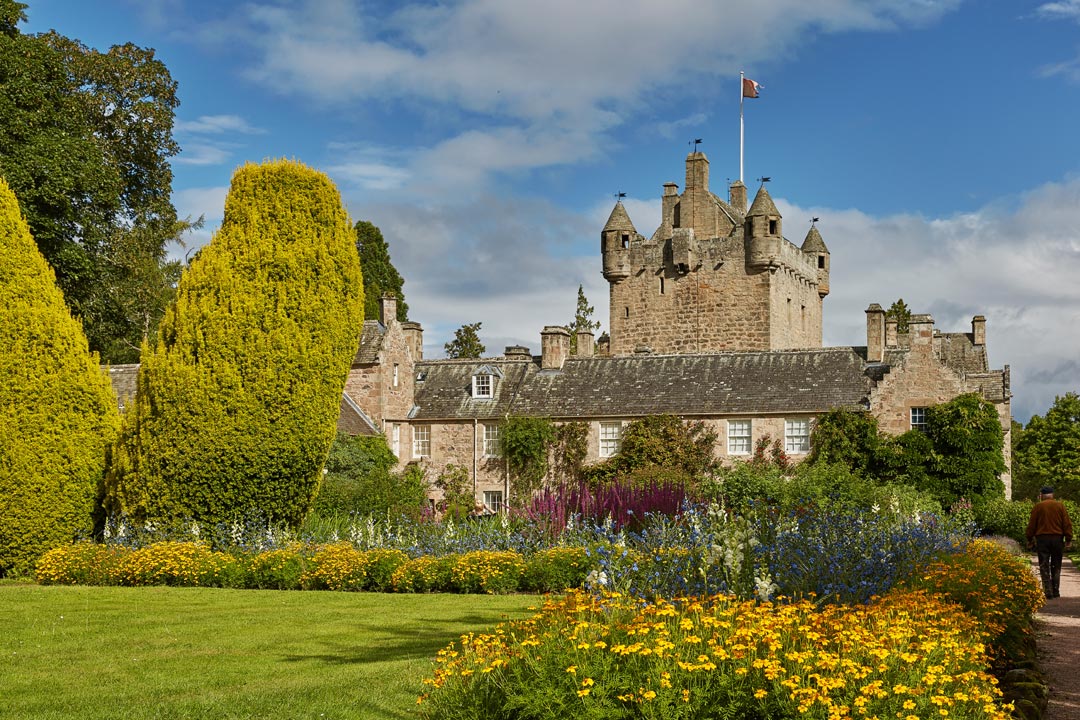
top-left (1013, 393), bottom-right (1080, 500)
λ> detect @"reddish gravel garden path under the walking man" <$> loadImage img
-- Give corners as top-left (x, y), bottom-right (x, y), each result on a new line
top-left (1032, 556), bottom-right (1080, 720)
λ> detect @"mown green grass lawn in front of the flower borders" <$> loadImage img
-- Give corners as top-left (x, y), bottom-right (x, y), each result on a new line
top-left (0, 585), bottom-right (540, 720)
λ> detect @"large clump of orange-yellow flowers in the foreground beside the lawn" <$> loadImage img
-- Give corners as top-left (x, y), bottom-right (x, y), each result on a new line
top-left (420, 592), bottom-right (1012, 720)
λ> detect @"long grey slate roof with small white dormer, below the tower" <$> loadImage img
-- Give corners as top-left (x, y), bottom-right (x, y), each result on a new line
top-left (410, 348), bottom-right (873, 421)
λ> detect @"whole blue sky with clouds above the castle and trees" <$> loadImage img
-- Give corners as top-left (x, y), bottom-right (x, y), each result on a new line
top-left (23, 0), bottom-right (1080, 421)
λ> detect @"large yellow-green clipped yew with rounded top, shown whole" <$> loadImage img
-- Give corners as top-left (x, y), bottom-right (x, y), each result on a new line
top-left (106, 161), bottom-right (363, 526)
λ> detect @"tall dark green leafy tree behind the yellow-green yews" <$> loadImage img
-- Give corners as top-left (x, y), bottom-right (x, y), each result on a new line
top-left (0, 5), bottom-right (184, 362)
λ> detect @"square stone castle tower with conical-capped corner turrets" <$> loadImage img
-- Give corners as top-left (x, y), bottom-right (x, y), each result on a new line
top-left (600, 152), bottom-right (829, 355)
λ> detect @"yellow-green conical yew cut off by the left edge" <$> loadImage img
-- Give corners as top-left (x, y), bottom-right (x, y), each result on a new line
top-left (0, 179), bottom-right (120, 575)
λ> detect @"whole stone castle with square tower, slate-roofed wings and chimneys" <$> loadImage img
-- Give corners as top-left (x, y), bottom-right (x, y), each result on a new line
top-left (110, 152), bottom-right (1012, 511)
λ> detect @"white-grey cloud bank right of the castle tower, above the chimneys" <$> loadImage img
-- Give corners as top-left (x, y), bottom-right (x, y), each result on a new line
top-left (777, 179), bottom-right (1080, 420)
